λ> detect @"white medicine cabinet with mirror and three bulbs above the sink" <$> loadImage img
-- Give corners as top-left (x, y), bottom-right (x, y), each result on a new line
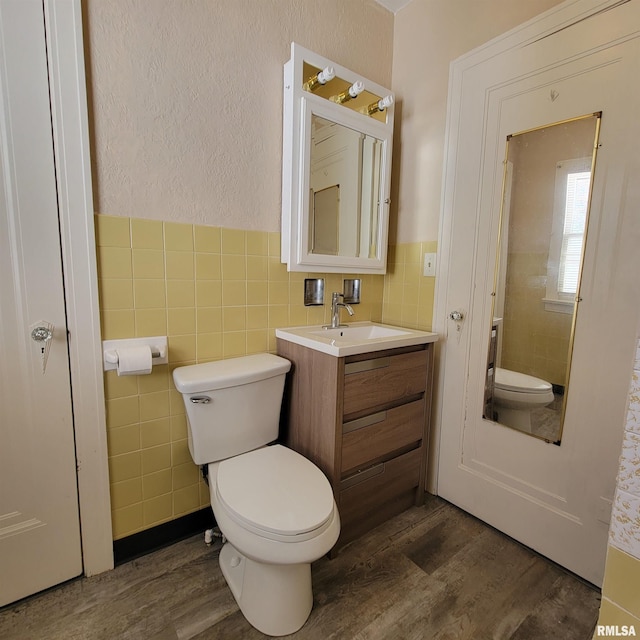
top-left (281, 43), bottom-right (394, 273)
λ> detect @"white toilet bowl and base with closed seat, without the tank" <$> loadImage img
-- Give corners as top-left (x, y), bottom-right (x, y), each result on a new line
top-left (209, 445), bottom-right (340, 636)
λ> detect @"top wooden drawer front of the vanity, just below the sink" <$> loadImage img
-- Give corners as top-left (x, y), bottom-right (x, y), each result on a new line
top-left (343, 349), bottom-right (427, 416)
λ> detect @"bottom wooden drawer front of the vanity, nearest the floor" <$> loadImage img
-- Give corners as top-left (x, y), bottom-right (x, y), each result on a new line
top-left (338, 448), bottom-right (423, 546)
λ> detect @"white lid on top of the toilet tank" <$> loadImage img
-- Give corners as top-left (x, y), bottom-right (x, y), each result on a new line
top-left (173, 353), bottom-right (291, 393)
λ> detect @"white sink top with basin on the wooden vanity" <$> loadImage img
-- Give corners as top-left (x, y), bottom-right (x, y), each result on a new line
top-left (276, 322), bottom-right (437, 357)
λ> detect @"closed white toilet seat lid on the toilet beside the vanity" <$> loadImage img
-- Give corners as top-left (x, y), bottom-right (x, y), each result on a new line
top-left (215, 445), bottom-right (335, 542)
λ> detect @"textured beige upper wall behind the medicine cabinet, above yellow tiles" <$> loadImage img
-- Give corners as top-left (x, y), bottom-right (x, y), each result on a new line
top-left (83, 0), bottom-right (393, 231)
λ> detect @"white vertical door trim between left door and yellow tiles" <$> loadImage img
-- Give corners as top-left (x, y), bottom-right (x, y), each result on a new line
top-left (44, 0), bottom-right (113, 575)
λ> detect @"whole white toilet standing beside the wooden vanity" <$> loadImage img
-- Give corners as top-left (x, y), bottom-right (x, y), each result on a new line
top-left (173, 353), bottom-right (340, 636)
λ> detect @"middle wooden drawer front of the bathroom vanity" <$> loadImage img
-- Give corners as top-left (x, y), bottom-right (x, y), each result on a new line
top-left (341, 400), bottom-right (424, 474)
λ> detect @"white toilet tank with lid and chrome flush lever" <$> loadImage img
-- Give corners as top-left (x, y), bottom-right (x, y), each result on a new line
top-left (173, 353), bottom-right (291, 465)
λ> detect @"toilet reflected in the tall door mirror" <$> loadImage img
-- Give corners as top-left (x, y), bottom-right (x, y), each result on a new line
top-left (493, 367), bottom-right (553, 433)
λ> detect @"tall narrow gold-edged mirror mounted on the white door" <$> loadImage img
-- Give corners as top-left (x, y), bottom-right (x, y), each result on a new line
top-left (483, 113), bottom-right (601, 444)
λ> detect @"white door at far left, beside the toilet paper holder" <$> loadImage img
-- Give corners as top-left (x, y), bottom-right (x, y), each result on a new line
top-left (0, 0), bottom-right (82, 606)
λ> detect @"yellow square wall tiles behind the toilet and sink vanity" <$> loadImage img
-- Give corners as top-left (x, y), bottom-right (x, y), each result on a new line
top-left (96, 214), bottom-right (435, 539)
